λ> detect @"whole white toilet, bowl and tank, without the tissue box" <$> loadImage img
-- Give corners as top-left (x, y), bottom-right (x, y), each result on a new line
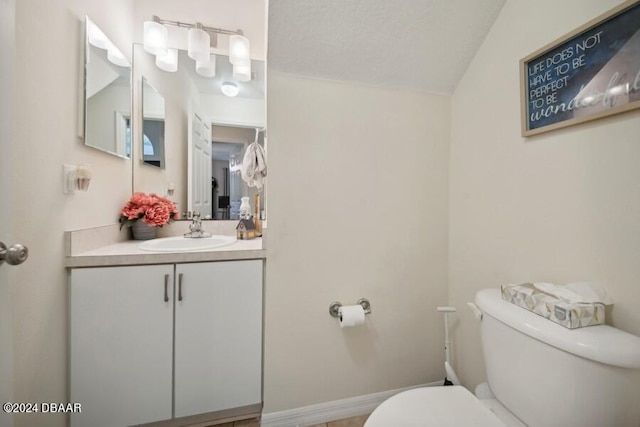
top-left (364, 289), bottom-right (640, 427)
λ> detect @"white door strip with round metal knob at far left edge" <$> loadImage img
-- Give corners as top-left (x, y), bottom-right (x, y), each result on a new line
top-left (0, 0), bottom-right (16, 427)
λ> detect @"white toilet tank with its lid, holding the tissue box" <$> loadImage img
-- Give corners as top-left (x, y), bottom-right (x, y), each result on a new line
top-left (475, 289), bottom-right (640, 427)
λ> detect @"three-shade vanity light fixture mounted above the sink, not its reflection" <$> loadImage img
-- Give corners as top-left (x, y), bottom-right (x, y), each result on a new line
top-left (144, 15), bottom-right (251, 82)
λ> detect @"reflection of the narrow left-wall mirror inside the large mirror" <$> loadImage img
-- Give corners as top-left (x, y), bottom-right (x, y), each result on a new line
top-left (141, 77), bottom-right (165, 169)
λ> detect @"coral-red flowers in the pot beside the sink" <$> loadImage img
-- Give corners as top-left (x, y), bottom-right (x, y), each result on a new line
top-left (120, 193), bottom-right (178, 228)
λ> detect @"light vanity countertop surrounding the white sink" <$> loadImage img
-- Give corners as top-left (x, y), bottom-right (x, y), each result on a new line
top-left (65, 238), bottom-right (266, 268)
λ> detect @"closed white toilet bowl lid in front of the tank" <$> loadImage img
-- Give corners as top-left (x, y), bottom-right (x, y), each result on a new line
top-left (364, 385), bottom-right (508, 427)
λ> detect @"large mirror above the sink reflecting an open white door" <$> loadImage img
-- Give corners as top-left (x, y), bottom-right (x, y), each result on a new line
top-left (133, 44), bottom-right (266, 220)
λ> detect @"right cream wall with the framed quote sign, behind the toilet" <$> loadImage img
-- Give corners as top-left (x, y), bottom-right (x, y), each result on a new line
top-left (449, 0), bottom-right (640, 389)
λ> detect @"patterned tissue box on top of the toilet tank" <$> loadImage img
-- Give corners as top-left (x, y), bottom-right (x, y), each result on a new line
top-left (500, 283), bottom-right (604, 329)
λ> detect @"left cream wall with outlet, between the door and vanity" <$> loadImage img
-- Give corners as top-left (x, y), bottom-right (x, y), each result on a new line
top-left (12, 0), bottom-right (132, 427)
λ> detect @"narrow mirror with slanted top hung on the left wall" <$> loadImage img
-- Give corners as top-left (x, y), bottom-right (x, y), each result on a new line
top-left (84, 17), bottom-right (131, 158)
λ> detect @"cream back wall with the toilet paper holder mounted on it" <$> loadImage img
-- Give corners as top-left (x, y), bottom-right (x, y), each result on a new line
top-left (264, 71), bottom-right (450, 413)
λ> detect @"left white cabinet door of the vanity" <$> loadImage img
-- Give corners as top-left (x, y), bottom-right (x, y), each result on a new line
top-left (71, 265), bottom-right (173, 427)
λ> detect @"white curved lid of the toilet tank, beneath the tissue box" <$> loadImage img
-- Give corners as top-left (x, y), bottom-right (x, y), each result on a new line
top-left (475, 289), bottom-right (640, 369)
